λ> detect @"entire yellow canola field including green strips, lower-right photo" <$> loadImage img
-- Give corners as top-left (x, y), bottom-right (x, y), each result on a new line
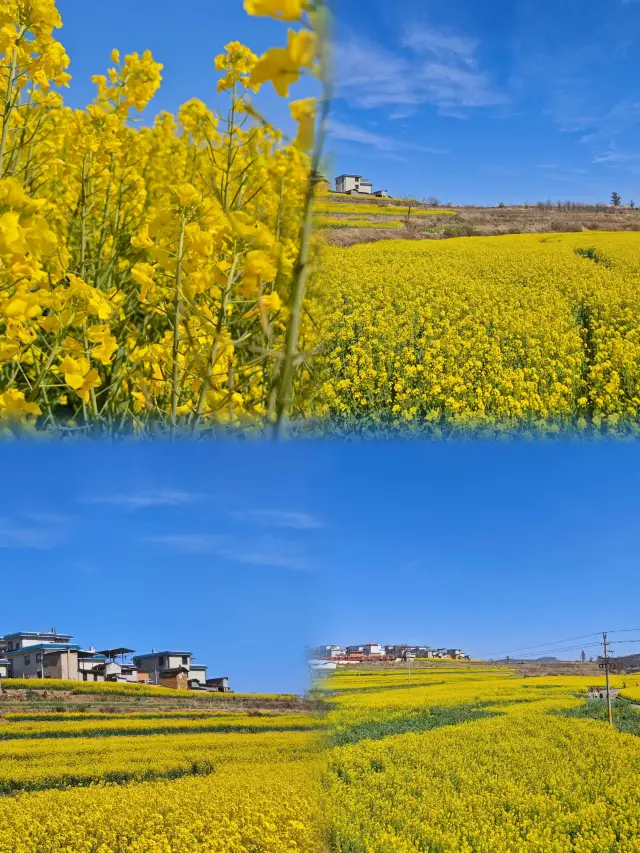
top-left (325, 667), bottom-right (640, 853)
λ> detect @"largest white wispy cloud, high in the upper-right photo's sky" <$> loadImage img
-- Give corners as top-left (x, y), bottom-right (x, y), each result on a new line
top-left (336, 22), bottom-right (507, 116)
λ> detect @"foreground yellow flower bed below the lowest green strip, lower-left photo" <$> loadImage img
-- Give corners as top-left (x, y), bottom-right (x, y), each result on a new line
top-left (0, 762), bottom-right (324, 853)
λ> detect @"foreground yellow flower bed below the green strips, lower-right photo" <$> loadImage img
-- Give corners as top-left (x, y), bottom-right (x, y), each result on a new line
top-left (327, 715), bottom-right (640, 853)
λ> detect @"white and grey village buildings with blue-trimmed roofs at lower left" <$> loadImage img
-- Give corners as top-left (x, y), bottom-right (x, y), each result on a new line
top-left (0, 628), bottom-right (229, 693)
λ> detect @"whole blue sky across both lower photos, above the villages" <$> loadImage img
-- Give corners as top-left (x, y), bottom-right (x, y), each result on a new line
top-left (0, 441), bottom-right (640, 691)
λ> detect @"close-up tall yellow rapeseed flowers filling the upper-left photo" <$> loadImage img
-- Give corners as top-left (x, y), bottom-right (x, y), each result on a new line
top-left (0, 0), bottom-right (322, 432)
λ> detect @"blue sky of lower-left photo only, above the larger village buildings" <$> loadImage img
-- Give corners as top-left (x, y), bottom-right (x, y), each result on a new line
top-left (0, 443), bottom-right (322, 692)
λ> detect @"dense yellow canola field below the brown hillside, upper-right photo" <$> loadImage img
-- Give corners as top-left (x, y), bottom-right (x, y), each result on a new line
top-left (317, 233), bottom-right (640, 434)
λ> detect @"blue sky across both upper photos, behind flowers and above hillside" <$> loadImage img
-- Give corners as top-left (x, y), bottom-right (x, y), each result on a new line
top-left (59, 0), bottom-right (640, 204)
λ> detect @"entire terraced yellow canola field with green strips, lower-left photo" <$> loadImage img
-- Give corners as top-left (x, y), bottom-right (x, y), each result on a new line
top-left (0, 700), bottom-right (321, 853)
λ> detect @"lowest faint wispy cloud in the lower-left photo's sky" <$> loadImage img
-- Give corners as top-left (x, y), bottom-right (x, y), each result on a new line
top-left (142, 533), bottom-right (311, 571)
